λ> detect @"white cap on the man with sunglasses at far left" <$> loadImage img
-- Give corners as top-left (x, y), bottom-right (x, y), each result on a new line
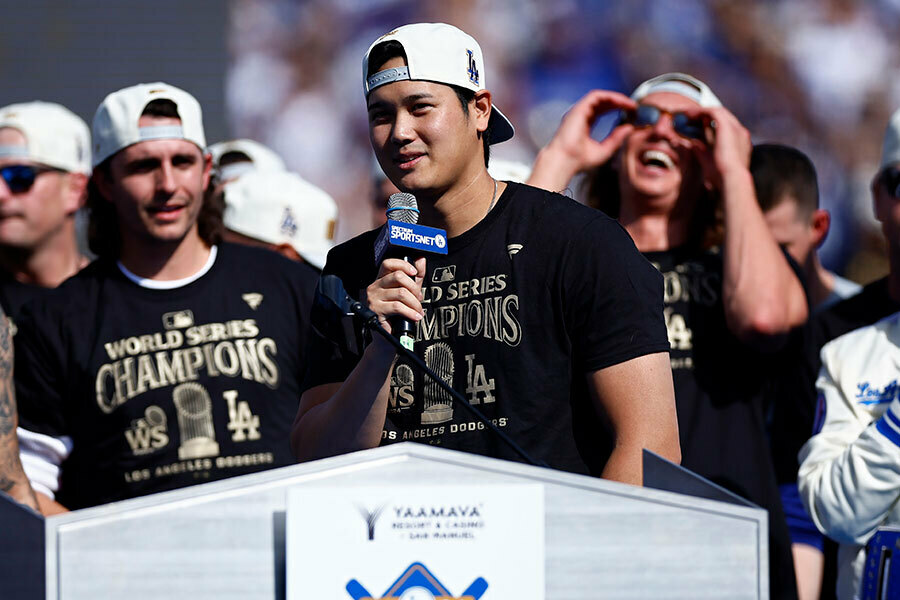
top-left (0, 101), bottom-right (91, 175)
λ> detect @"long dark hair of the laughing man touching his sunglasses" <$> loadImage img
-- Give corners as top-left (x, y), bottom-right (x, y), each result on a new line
top-left (581, 159), bottom-right (725, 249)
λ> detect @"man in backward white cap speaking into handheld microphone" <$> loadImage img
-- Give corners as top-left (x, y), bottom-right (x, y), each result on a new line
top-left (291, 23), bottom-right (680, 484)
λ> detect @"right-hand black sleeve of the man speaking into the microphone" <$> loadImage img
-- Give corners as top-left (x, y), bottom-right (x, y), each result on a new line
top-left (564, 215), bottom-right (669, 372)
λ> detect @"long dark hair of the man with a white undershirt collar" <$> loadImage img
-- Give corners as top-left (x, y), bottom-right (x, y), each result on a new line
top-left (87, 100), bottom-right (225, 259)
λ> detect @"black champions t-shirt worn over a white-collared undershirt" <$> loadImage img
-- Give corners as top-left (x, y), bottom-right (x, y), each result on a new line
top-left (16, 244), bottom-right (317, 508)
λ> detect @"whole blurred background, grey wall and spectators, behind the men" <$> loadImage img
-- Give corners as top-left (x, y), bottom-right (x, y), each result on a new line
top-left (0, 0), bottom-right (900, 283)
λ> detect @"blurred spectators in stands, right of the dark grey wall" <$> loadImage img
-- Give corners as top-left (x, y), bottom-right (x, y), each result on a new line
top-left (225, 0), bottom-right (900, 281)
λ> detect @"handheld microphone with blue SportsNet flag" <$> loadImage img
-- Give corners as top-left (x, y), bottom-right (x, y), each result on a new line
top-left (375, 192), bottom-right (447, 350)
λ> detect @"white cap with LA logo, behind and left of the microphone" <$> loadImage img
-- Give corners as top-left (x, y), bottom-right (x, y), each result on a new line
top-left (225, 171), bottom-right (338, 269)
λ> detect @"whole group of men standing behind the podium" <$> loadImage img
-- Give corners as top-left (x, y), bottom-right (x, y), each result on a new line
top-left (0, 12), bottom-right (900, 599)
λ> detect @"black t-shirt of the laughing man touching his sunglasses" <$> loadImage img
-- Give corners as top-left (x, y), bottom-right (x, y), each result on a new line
top-left (644, 248), bottom-right (796, 598)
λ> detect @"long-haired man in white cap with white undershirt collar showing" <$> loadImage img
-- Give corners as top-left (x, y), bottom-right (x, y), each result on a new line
top-left (16, 83), bottom-right (316, 510)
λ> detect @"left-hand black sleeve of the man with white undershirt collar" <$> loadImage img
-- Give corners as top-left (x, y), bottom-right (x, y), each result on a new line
top-left (15, 300), bottom-right (71, 437)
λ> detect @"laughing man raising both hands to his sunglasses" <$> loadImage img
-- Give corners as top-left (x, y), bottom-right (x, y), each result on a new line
top-left (529, 73), bottom-right (807, 598)
